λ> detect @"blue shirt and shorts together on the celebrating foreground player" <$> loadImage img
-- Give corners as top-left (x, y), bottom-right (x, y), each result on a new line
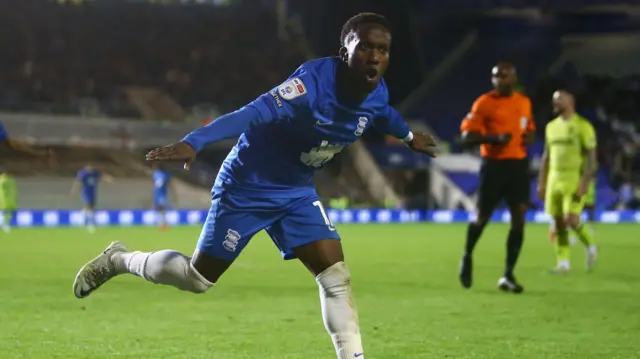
top-left (183, 57), bottom-right (411, 260)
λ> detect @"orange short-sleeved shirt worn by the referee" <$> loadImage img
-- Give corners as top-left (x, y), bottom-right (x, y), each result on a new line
top-left (460, 91), bottom-right (536, 160)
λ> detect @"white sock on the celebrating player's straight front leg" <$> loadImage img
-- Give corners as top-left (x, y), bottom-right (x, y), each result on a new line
top-left (316, 262), bottom-right (364, 359)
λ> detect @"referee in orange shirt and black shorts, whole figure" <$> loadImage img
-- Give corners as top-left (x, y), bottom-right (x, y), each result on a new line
top-left (459, 62), bottom-right (536, 293)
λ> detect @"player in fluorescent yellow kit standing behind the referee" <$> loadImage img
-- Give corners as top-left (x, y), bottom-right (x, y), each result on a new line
top-left (538, 91), bottom-right (597, 273)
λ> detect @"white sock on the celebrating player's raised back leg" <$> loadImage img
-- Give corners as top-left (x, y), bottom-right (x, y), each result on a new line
top-left (113, 249), bottom-right (213, 293)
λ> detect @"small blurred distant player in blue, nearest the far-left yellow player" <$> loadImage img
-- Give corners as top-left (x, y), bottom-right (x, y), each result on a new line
top-left (69, 164), bottom-right (113, 233)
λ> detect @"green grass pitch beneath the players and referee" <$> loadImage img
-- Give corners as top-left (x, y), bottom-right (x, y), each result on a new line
top-left (0, 224), bottom-right (640, 359)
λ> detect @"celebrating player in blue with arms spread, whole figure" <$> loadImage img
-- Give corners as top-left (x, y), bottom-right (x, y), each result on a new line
top-left (73, 13), bottom-right (435, 359)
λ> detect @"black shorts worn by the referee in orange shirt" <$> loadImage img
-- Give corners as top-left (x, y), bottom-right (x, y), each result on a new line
top-left (478, 158), bottom-right (530, 213)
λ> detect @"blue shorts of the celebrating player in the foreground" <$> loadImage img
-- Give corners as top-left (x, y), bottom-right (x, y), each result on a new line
top-left (198, 192), bottom-right (340, 261)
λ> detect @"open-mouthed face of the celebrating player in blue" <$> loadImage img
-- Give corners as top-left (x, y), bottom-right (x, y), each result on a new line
top-left (345, 24), bottom-right (391, 91)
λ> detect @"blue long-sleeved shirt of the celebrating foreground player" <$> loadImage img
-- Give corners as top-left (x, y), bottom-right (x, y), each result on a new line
top-left (183, 57), bottom-right (409, 198)
